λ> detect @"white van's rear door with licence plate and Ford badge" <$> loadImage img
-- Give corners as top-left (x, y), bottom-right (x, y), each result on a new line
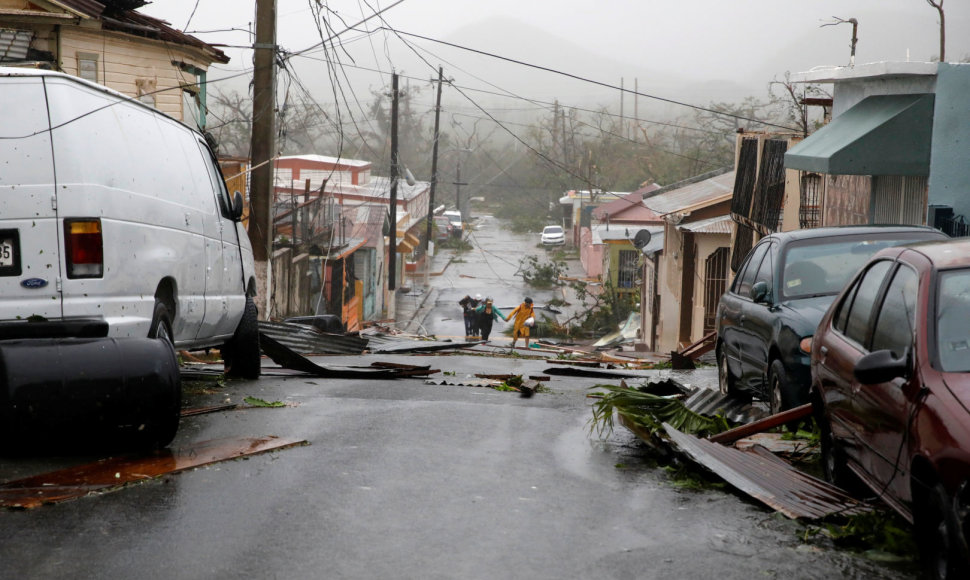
top-left (0, 75), bottom-right (62, 320)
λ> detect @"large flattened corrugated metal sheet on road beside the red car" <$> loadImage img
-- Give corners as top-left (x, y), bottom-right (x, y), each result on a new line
top-left (664, 424), bottom-right (870, 519)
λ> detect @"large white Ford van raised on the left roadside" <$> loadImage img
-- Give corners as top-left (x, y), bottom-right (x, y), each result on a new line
top-left (0, 67), bottom-right (260, 378)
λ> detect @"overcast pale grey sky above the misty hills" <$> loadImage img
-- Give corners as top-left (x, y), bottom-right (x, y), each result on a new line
top-left (141, 0), bottom-right (970, 113)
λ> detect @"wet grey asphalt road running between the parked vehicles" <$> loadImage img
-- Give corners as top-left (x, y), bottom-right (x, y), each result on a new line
top-left (0, 223), bottom-right (912, 579)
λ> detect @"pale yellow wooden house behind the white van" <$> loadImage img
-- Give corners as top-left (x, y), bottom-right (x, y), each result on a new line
top-left (0, 0), bottom-right (229, 129)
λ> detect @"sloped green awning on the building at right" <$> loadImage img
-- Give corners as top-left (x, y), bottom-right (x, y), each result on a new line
top-left (785, 94), bottom-right (934, 176)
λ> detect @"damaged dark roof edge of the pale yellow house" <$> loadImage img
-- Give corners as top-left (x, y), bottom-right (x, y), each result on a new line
top-left (49, 0), bottom-right (229, 64)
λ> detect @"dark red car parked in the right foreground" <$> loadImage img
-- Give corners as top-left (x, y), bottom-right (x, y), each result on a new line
top-left (811, 239), bottom-right (970, 578)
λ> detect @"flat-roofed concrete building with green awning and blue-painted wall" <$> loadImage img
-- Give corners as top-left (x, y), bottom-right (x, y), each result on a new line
top-left (785, 62), bottom-right (970, 236)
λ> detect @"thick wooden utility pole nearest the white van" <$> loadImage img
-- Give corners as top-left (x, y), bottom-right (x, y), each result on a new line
top-left (248, 0), bottom-right (276, 318)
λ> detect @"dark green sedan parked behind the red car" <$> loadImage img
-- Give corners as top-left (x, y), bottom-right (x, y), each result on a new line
top-left (717, 226), bottom-right (947, 413)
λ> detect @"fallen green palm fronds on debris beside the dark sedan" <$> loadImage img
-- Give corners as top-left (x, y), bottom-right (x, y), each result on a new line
top-left (589, 385), bottom-right (731, 437)
